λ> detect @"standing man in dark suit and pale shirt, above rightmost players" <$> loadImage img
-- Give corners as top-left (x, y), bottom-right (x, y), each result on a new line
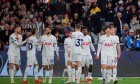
top-left (114, 12), bottom-right (123, 36)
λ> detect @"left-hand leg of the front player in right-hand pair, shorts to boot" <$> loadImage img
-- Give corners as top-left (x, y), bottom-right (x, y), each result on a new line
top-left (101, 55), bottom-right (107, 84)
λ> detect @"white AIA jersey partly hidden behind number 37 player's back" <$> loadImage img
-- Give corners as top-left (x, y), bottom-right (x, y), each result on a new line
top-left (83, 35), bottom-right (95, 54)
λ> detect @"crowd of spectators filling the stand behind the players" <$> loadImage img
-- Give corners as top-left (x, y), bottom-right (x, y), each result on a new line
top-left (0, 0), bottom-right (140, 50)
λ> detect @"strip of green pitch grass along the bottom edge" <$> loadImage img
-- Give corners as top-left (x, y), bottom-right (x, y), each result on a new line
top-left (0, 77), bottom-right (140, 84)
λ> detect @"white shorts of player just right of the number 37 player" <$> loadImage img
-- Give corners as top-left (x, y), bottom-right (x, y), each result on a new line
top-left (82, 54), bottom-right (93, 67)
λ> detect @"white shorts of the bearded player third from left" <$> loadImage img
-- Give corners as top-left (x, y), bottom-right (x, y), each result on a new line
top-left (42, 56), bottom-right (54, 65)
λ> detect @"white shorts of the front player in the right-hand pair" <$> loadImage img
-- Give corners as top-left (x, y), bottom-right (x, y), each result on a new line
top-left (101, 54), bottom-right (114, 66)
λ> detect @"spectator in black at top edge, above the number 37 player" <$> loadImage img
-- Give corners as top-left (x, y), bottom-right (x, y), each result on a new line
top-left (70, 0), bottom-right (82, 17)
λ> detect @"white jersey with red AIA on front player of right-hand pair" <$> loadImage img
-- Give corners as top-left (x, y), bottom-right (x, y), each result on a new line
top-left (97, 35), bottom-right (116, 56)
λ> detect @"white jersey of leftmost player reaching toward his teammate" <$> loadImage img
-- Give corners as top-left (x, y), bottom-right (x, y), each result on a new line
top-left (7, 33), bottom-right (26, 55)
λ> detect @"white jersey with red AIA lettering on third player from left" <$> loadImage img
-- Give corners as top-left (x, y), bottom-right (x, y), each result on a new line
top-left (41, 35), bottom-right (58, 56)
